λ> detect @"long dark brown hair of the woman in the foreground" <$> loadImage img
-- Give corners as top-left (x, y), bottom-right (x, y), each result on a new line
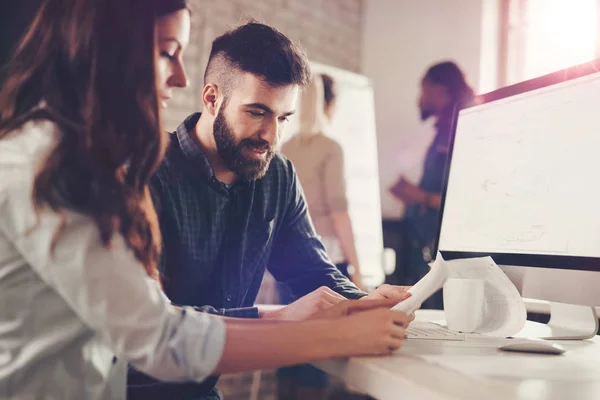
top-left (0, 0), bottom-right (166, 277)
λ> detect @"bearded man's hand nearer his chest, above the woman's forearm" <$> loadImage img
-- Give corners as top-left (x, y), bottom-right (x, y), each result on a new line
top-left (260, 286), bottom-right (346, 321)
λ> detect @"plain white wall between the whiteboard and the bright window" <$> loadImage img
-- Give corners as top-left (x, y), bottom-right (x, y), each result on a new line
top-left (362, 0), bottom-right (488, 218)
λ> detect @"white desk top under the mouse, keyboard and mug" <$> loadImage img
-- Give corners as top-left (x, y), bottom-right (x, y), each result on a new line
top-left (315, 310), bottom-right (600, 400)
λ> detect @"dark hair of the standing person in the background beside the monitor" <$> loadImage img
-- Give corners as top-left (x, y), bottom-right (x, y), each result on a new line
top-left (423, 61), bottom-right (474, 106)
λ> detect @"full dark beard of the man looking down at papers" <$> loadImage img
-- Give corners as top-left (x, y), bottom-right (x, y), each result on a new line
top-left (213, 107), bottom-right (275, 181)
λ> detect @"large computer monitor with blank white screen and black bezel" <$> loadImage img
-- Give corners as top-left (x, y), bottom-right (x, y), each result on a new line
top-left (437, 61), bottom-right (600, 340)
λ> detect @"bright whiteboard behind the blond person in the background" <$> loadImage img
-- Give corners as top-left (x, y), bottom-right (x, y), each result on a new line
top-left (282, 63), bottom-right (385, 287)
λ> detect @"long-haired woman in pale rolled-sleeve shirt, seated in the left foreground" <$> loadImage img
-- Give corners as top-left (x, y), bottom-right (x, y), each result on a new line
top-left (0, 0), bottom-right (408, 400)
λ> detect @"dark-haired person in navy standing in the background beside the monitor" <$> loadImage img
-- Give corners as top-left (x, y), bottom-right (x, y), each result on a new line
top-left (390, 61), bottom-right (474, 308)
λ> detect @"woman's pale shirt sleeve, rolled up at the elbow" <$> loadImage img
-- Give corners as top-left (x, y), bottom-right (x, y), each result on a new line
top-left (0, 174), bottom-right (226, 382)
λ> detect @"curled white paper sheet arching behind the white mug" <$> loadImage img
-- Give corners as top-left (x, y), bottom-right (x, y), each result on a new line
top-left (393, 253), bottom-right (527, 337)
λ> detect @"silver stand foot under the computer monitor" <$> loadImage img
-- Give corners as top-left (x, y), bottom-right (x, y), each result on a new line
top-left (539, 302), bottom-right (598, 340)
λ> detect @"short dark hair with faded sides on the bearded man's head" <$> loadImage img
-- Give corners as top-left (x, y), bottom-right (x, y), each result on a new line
top-left (204, 22), bottom-right (311, 94)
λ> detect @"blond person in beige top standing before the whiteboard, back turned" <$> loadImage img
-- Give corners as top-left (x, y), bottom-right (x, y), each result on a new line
top-left (277, 75), bottom-right (363, 400)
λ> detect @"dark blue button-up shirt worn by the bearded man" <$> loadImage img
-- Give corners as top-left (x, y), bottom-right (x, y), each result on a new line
top-left (128, 113), bottom-right (365, 399)
